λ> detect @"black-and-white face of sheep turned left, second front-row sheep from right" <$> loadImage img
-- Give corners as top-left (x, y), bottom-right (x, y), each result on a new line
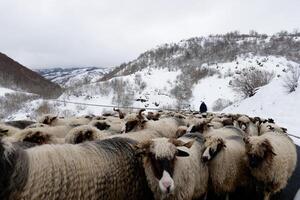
top-left (201, 137), bottom-right (226, 162)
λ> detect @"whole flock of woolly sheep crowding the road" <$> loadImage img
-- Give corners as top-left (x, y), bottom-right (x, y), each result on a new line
top-left (0, 109), bottom-right (297, 200)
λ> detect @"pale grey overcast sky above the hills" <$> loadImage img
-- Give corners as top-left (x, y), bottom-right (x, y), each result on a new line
top-left (0, 0), bottom-right (300, 68)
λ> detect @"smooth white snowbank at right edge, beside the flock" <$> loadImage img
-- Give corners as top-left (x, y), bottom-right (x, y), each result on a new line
top-left (223, 79), bottom-right (300, 144)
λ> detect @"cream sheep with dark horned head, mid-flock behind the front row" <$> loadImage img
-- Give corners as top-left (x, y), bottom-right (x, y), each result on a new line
top-left (122, 109), bottom-right (186, 137)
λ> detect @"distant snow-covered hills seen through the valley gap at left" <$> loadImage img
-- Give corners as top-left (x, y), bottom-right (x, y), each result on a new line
top-left (36, 67), bottom-right (110, 87)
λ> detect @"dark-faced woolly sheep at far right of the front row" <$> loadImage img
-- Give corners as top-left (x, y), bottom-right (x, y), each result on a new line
top-left (244, 132), bottom-right (297, 200)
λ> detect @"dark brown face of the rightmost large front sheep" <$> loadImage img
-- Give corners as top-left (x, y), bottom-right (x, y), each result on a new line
top-left (244, 136), bottom-right (276, 168)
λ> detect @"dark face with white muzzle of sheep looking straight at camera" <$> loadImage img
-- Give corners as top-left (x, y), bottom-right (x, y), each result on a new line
top-left (137, 138), bottom-right (193, 195)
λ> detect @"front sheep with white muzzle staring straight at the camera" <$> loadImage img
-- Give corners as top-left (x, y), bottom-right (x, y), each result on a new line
top-left (137, 135), bottom-right (208, 200)
